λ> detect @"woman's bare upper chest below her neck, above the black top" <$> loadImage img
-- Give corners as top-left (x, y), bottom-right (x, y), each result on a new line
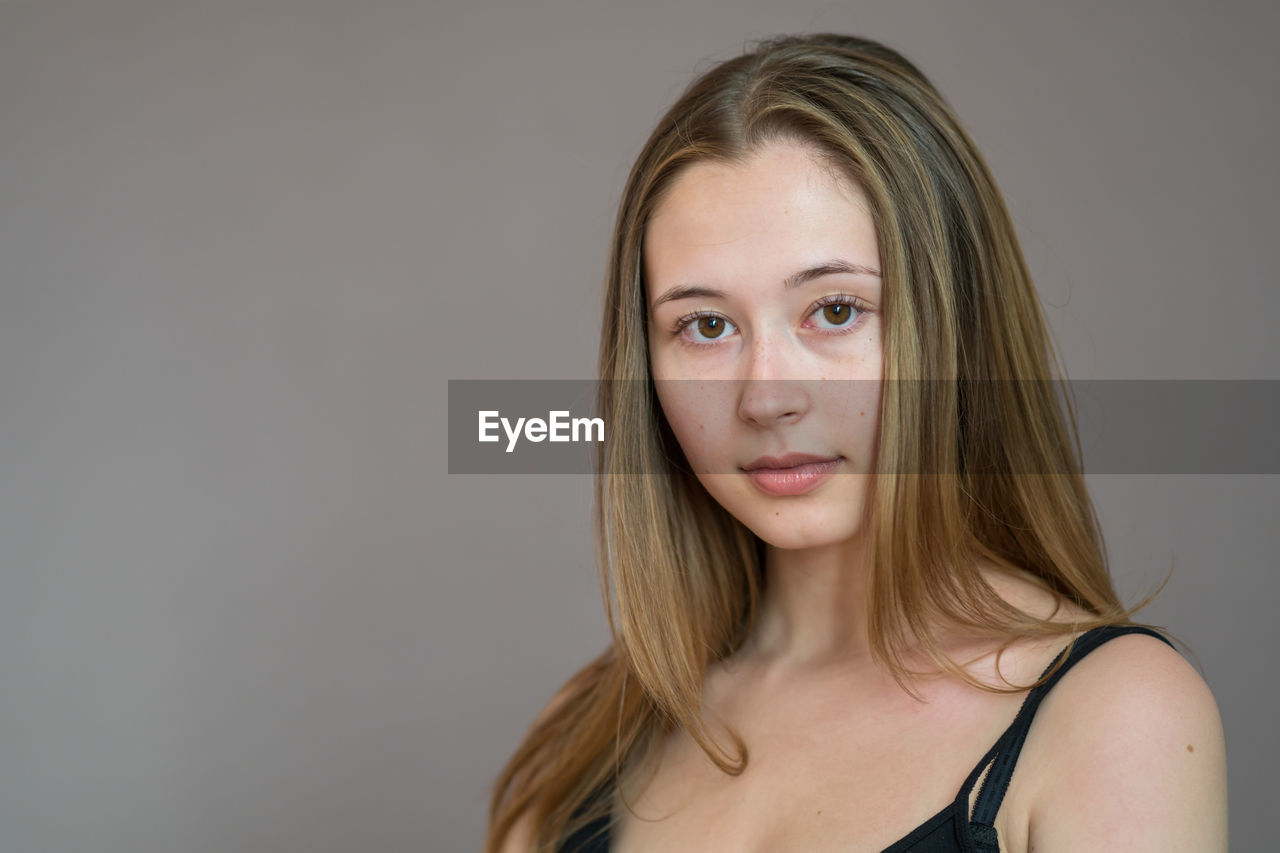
top-left (611, 648), bottom-right (1048, 853)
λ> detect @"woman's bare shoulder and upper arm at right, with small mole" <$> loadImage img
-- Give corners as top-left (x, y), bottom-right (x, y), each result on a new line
top-left (1028, 633), bottom-right (1226, 853)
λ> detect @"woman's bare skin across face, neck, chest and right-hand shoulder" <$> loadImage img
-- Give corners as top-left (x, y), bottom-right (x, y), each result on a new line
top-left (613, 143), bottom-right (1226, 853)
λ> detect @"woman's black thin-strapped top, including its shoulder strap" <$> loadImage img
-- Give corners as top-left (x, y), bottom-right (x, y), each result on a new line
top-left (558, 625), bottom-right (1172, 853)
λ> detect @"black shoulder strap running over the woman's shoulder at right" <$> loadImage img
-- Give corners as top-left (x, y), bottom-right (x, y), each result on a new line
top-left (963, 625), bottom-right (1176, 829)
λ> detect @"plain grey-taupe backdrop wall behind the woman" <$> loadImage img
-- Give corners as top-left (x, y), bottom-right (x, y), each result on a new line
top-left (0, 0), bottom-right (1280, 853)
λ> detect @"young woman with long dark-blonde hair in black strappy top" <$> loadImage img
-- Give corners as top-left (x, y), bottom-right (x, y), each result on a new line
top-left (486, 35), bottom-right (1226, 853)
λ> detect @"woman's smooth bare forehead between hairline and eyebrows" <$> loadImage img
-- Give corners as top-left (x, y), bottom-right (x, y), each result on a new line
top-left (644, 143), bottom-right (879, 286)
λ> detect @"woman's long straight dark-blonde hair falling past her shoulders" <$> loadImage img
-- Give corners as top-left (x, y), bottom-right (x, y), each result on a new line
top-left (486, 33), bottom-right (1167, 853)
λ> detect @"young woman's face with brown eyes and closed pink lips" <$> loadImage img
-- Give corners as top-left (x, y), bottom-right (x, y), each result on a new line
top-left (644, 142), bottom-right (883, 548)
